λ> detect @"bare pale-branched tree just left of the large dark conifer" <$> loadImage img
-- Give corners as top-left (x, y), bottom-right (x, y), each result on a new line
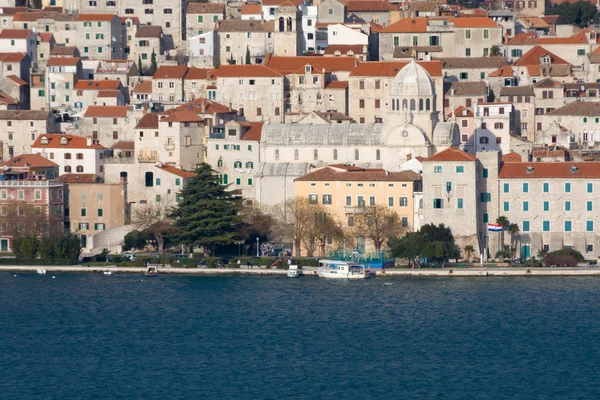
top-left (131, 197), bottom-right (175, 253)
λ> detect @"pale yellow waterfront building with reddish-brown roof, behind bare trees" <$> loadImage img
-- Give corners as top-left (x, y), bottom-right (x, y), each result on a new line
top-left (294, 164), bottom-right (422, 251)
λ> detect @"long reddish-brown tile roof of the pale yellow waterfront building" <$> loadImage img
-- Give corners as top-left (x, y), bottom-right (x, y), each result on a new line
top-left (294, 165), bottom-right (421, 182)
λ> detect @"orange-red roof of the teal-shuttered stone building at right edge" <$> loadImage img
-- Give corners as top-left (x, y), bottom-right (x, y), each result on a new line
top-left (498, 162), bottom-right (600, 179)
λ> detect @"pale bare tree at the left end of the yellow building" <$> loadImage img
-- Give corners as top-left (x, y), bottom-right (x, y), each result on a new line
top-left (272, 196), bottom-right (313, 257)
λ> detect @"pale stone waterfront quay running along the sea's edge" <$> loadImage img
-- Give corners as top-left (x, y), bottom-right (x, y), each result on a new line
top-left (0, 265), bottom-right (600, 278)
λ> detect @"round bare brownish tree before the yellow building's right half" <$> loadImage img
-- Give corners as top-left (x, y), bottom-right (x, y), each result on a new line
top-left (354, 205), bottom-right (406, 252)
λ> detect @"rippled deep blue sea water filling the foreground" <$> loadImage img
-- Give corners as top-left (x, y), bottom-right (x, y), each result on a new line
top-left (0, 274), bottom-right (600, 399)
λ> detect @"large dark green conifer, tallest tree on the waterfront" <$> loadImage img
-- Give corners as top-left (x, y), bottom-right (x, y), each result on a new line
top-left (171, 163), bottom-right (242, 253)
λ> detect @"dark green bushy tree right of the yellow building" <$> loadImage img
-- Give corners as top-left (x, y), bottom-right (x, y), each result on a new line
top-left (389, 224), bottom-right (460, 266)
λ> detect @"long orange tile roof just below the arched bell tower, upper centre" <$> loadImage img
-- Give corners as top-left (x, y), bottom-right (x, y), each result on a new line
top-left (265, 56), bottom-right (357, 75)
